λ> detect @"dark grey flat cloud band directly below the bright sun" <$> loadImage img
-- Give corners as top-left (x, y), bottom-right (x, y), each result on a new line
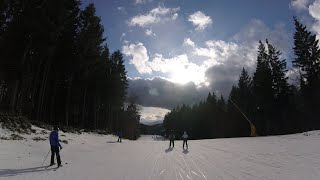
top-left (128, 77), bottom-right (209, 109)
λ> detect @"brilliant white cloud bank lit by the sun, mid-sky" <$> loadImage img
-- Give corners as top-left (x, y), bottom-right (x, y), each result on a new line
top-left (122, 43), bottom-right (206, 85)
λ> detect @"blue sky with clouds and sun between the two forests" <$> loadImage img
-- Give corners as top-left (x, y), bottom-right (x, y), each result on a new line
top-left (82, 0), bottom-right (320, 124)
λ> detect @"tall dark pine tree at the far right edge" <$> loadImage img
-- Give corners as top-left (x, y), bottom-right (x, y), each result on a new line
top-left (292, 17), bottom-right (320, 129)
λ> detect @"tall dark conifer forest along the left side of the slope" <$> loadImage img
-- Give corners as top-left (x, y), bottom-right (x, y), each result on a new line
top-left (0, 0), bottom-right (140, 139)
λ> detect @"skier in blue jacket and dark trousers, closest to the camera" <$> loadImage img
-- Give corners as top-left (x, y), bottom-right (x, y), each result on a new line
top-left (50, 126), bottom-right (62, 167)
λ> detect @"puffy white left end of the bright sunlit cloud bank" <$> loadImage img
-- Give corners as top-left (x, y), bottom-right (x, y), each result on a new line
top-left (122, 43), bottom-right (152, 74)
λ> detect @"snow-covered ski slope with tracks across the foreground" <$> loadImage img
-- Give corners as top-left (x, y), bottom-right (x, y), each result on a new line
top-left (0, 126), bottom-right (320, 180)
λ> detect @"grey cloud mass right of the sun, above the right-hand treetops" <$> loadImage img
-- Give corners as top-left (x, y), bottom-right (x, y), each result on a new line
top-left (193, 20), bottom-right (290, 96)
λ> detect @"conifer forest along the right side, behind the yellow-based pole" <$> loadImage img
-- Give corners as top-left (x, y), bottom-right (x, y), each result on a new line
top-left (164, 17), bottom-right (320, 139)
